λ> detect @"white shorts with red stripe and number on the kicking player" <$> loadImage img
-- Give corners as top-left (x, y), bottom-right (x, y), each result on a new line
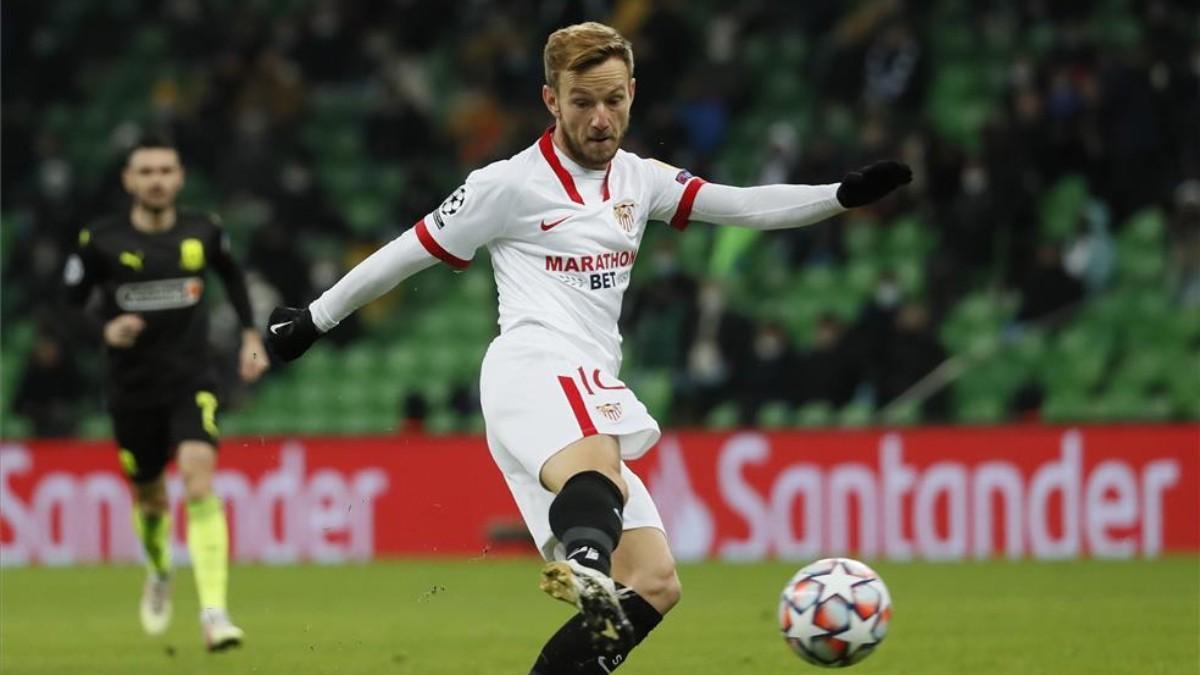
top-left (479, 324), bottom-right (664, 560)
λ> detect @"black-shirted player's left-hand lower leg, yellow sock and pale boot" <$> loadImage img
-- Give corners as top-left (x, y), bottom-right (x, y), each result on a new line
top-left (133, 475), bottom-right (172, 635)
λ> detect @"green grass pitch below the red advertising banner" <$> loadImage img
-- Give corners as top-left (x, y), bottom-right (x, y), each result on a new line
top-left (0, 557), bottom-right (1200, 675)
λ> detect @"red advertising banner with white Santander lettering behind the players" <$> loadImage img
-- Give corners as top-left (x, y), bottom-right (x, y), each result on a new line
top-left (0, 425), bottom-right (1200, 565)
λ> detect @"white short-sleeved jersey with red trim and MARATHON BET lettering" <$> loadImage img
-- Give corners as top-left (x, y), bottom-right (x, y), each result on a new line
top-left (416, 129), bottom-right (704, 374)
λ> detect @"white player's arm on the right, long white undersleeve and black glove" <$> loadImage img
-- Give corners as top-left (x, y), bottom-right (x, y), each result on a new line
top-left (690, 160), bottom-right (912, 229)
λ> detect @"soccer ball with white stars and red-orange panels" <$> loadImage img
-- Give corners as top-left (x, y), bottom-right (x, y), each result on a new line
top-left (779, 557), bottom-right (892, 668)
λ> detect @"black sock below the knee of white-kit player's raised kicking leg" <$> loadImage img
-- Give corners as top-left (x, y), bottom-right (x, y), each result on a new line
top-left (550, 471), bottom-right (625, 574)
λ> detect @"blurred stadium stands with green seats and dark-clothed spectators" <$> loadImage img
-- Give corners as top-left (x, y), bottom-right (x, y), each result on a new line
top-left (0, 0), bottom-right (1200, 436)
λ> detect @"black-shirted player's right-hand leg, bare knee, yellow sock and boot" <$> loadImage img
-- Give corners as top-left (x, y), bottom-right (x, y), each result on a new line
top-left (178, 441), bottom-right (244, 651)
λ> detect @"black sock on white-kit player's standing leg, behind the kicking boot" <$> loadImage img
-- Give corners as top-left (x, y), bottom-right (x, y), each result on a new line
top-left (529, 584), bottom-right (662, 675)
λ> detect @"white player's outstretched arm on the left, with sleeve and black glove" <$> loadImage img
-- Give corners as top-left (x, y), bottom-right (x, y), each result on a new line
top-left (266, 162), bottom-right (510, 362)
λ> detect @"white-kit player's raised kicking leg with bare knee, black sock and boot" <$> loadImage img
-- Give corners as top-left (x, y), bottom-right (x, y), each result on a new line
top-left (540, 435), bottom-right (634, 652)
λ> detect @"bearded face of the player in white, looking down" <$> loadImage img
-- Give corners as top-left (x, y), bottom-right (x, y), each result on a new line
top-left (542, 56), bottom-right (635, 169)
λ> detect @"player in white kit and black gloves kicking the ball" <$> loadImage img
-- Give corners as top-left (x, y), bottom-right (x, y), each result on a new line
top-left (268, 23), bottom-right (912, 675)
